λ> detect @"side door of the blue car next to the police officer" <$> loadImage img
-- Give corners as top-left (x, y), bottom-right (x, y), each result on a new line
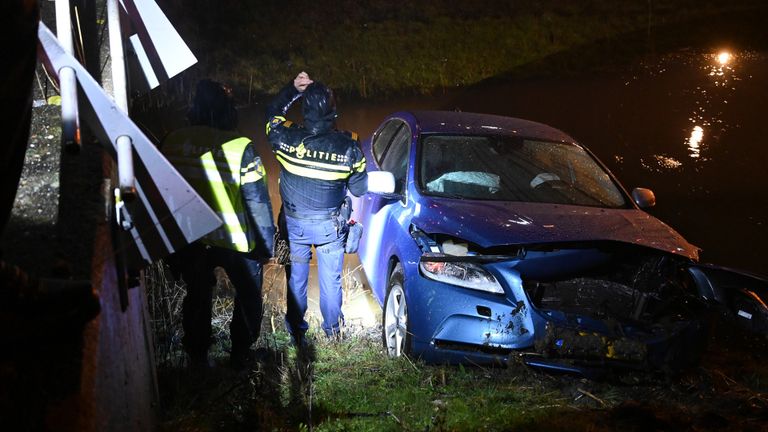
top-left (355, 118), bottom-right (411, 302)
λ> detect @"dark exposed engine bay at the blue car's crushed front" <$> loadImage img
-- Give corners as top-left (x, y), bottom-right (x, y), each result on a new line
top-left (524, 251), bottom-right (707, 369)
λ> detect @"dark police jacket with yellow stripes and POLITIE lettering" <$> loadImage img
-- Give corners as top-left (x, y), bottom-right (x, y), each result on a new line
top-left (266, 84), bottom-right (368, 217)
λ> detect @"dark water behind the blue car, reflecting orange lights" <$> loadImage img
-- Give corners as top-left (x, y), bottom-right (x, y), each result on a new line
top-left (241, 51), bottom-right (768, 274)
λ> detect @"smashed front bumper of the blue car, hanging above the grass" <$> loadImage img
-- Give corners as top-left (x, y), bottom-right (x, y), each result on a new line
top-left (417, 264), bottom-right (707, 376)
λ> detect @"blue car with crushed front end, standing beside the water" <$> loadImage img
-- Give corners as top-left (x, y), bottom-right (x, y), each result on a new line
top-left (353, 111), bottom-right (768, 373)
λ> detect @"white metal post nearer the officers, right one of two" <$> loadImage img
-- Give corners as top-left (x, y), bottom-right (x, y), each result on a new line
top-left (107, 0), bottom-right (136, 201)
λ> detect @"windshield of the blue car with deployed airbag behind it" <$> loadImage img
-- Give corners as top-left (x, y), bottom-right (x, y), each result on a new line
top-left (419, 135), bottom-right (627, 208)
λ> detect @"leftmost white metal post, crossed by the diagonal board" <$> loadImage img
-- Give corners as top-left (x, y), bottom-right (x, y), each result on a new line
top-left (56, 0), bottom-right (80, 153)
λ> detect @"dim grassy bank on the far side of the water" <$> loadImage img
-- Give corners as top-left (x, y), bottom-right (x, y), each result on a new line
top-left (159, 0), bottom-right (765, 98)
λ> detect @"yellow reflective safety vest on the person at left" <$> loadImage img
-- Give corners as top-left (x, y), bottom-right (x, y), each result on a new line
top-left (161, 126), bottom-right (265, 252)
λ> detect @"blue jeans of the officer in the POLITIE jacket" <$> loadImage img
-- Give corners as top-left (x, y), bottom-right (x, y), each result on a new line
top-left (285, 215), bottom-right (344, 339)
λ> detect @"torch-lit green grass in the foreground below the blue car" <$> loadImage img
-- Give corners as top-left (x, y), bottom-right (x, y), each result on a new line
top-left (152, 318), bottom-right (618, 431)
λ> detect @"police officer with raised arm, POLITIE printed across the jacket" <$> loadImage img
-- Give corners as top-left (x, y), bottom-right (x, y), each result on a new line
top-left (266, 72), bottom-right (368, 346)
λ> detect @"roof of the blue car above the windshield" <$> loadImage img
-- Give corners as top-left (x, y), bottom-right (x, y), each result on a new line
top-left (400, 111), bottom-right (576, 143)
